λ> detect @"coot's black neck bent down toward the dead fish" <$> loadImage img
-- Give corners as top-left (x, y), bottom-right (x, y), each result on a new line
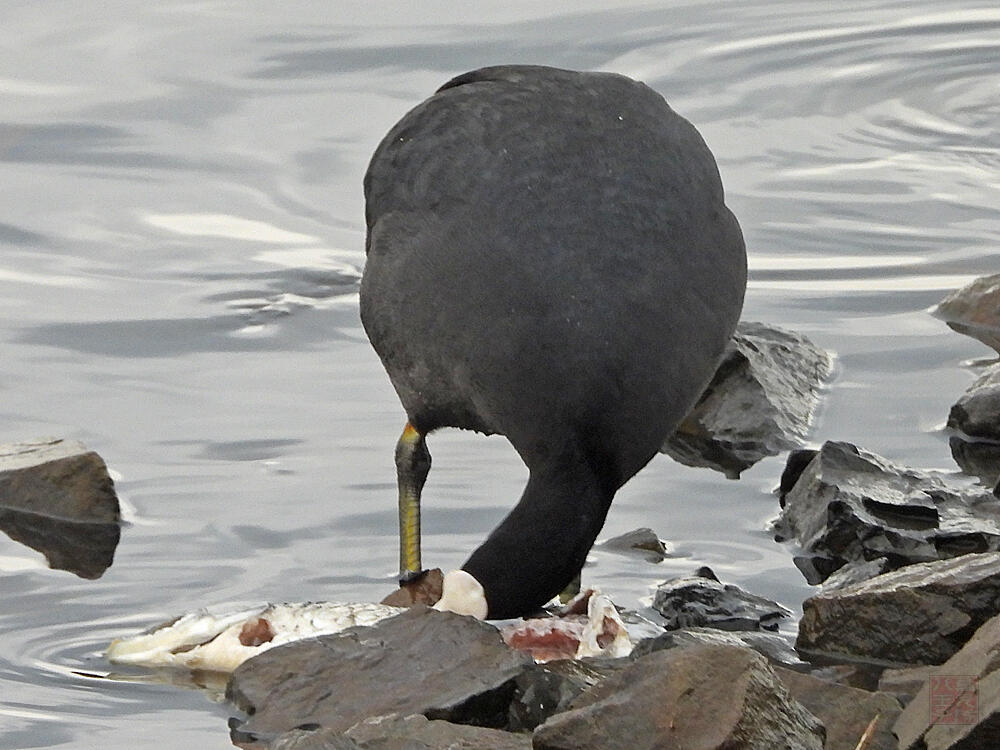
top-left (462, 451), bottom-right (614, 619)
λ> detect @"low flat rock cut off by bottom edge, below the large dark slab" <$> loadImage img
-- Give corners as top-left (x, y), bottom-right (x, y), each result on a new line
top-left (269, 714), bottom-right (531, 750)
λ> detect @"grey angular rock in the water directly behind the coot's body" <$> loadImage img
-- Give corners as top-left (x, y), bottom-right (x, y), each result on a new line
top-left (660, 321), bottom-right (832, 478)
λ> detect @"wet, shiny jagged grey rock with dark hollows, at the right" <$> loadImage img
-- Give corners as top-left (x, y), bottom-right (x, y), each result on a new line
top-left (775, 442), bottom-right (1000, 583)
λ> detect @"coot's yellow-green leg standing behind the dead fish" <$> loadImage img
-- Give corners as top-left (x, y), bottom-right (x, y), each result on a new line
top-left (396, 422), bottom-right (431, 583)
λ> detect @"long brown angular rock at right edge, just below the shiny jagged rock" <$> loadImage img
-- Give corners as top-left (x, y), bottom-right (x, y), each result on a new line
top-left (795, 552), bottom-right (1000, 666)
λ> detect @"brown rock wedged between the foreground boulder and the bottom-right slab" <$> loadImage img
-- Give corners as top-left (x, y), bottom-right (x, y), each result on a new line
top-left (773, 667), bottom-right (903, 750)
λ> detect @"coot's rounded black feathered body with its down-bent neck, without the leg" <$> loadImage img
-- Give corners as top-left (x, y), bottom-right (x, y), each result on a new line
top-left (361, 66), bottom-right (746, 618)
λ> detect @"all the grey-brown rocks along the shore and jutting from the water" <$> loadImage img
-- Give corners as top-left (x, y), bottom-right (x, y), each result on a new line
top-left (0, 275), bottom-right (1000, 750)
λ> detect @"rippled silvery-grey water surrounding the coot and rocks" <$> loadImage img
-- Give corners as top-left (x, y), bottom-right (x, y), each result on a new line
top-left (0, 0), bottom-right (1000, 750)
